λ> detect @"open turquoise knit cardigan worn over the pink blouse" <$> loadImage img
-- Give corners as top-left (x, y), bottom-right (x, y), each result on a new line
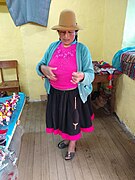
top-left (36, 41), bottom-right (94, 103)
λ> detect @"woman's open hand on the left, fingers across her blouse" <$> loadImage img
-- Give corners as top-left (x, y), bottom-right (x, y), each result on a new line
top-left (41, 65), bottom-right (57, 81)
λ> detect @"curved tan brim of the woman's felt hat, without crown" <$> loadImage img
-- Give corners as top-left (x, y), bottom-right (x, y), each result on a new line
top-left (51, 25), bottom-right (82, 31)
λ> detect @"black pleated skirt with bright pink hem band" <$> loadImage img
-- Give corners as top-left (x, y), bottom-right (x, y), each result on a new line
top-left (46, 87), bottom-right (94, 140)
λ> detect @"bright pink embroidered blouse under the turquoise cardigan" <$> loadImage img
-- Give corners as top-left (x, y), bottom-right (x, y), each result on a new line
top-left (49, 43), bottom-right (77, 90)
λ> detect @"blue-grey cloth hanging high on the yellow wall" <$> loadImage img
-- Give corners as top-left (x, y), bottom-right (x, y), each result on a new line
top-left (6, 0), bottom-right (51, 26)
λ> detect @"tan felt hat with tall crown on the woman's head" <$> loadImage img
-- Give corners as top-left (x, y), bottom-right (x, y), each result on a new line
top-left (52, 9), bottom-right (82, 31)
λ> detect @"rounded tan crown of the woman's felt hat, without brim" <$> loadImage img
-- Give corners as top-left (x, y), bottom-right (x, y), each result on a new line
top-left (59, 10), bottom-right (77, 27)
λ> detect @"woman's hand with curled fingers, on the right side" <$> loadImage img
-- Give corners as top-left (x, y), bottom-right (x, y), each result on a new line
top-left (71, 72), bottom-right (84, 84)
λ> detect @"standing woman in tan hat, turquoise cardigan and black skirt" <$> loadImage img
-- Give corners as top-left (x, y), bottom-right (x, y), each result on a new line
top-left (36, 10), bottom-right (94, 160)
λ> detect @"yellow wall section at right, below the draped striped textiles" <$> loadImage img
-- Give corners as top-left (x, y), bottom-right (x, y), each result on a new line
top-left (115, 75), bottom-right (135, 135)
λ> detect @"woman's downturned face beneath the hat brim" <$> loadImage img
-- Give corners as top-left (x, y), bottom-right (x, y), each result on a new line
top-left (58, 30), bottom-right (77, 46)
